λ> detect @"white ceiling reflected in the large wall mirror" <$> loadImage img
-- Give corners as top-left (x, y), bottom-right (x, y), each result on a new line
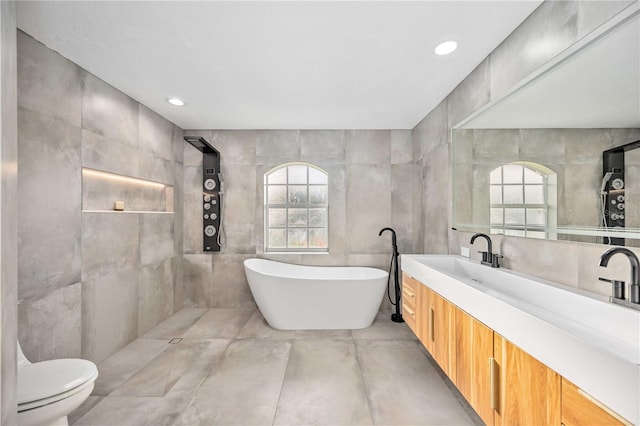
top-left (463, 16), bottom-right (640, 129)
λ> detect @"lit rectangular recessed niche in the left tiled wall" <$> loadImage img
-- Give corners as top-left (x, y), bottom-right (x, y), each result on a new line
top-left (82, 168), bottom-right (173, 213)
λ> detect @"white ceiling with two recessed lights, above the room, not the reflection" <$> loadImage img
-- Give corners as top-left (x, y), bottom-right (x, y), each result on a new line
top-left (17, 0), bottom-right (541, 129)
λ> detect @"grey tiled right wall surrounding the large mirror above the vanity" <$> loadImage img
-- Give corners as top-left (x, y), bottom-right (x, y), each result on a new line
top-left (413, 1), bottom-right (640, 295)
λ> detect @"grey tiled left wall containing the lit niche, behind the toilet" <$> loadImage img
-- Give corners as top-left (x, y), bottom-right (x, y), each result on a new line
top-left (17, 31), bottom-right (183, 362)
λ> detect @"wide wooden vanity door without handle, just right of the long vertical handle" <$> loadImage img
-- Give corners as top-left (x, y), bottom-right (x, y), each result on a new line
top-left (493, 331), bottom-right (561, 426)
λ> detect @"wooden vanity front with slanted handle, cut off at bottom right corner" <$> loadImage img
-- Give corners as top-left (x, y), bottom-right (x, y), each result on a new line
top-left (562, 378), bottom-right (630, 426)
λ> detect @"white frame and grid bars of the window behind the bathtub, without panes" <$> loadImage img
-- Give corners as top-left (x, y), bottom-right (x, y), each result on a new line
top-left (263, 162), bottom-right (330, 253)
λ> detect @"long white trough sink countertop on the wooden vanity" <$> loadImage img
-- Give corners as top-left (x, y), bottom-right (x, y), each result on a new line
top-left (401, 255), bottom-right (640, 424)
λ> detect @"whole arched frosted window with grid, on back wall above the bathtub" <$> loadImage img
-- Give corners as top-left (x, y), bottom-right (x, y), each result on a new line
top-left (264, 163), bottom-right (329, 252)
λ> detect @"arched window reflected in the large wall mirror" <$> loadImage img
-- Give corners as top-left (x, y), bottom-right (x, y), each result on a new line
top-left (489, 161), bottom-right (558, 239)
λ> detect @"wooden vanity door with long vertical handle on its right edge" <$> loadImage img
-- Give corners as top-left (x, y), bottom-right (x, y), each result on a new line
top-left (456, 308), bottom-right (498, 425)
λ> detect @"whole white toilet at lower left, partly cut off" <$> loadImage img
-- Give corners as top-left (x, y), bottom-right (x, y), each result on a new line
top-left (17, 342), bottom-right (98, 426)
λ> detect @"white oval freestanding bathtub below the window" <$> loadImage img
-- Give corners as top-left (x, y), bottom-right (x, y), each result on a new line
top-left (244, 259), bottom-right (388, 330)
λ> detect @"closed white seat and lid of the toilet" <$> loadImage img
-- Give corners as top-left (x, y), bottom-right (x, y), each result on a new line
top-left (17, 359), bottom-right (98, 412)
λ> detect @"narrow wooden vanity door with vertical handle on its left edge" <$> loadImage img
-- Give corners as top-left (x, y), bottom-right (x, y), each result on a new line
top-left (427, 290), bottom-right (456, 383)
